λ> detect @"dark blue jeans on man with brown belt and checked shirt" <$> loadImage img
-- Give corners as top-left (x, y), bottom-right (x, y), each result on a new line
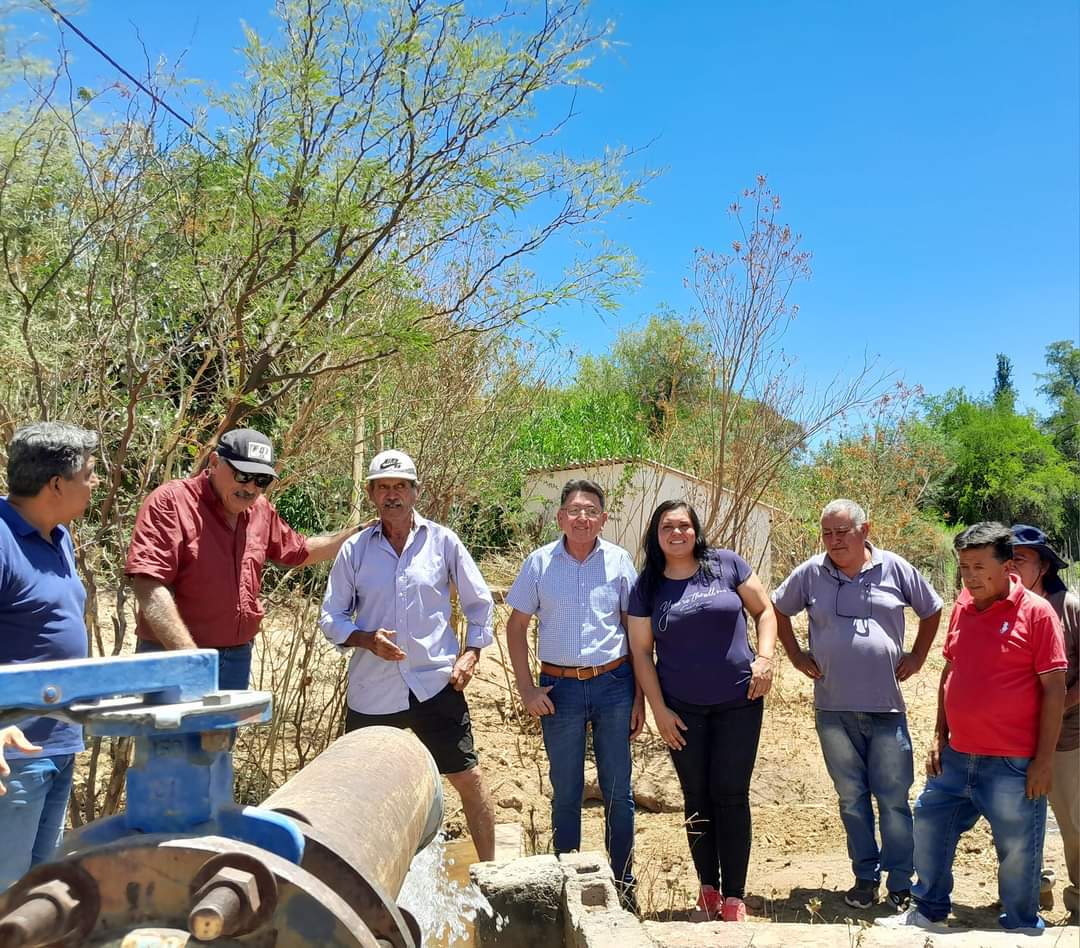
top-left (540, 661), bottom-right (634, 885)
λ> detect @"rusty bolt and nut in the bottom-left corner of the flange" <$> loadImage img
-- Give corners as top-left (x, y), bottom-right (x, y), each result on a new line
top-left (0, 859), bottom-right (100, 948)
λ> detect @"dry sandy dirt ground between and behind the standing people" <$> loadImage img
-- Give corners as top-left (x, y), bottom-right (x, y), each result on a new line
top-left (446, 604), bottom-right (1080, 929)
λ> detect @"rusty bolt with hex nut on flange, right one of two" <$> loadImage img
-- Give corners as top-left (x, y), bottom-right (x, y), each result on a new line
top-left (188, 852), bottom-right (278, 942)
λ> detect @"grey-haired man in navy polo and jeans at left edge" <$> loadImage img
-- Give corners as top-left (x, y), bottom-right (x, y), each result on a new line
top-left (0, 421), bottom-right (97, 892)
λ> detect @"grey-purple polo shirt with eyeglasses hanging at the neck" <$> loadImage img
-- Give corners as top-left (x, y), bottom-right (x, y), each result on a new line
top-left (772, 543), bottom-right (942, 712)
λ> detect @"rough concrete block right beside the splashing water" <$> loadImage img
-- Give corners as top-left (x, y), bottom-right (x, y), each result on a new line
top-left (469, 856), bottom-right (563, 948)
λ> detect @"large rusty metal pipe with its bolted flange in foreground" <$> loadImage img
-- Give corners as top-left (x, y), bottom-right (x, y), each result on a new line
top-left (0, 728), bottom-right (443, 948)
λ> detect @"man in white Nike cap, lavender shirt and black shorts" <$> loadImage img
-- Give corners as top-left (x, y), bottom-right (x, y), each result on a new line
top-left (319, 451), bottom-right (495, 861)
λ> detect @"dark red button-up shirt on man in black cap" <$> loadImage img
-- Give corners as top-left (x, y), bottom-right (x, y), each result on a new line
top-left (124, 471), bottom-right (308, 648)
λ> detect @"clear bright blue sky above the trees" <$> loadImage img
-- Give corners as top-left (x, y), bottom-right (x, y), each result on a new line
top-left (8, 0), bottom-right (1080, 410)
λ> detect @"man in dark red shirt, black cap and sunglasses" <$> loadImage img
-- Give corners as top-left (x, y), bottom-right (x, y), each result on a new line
top-left (124, 428), bottom-right (355, 689)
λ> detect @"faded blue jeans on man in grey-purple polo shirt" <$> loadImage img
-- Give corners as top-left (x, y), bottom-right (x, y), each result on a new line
top-left (816, 710), bottom-right (915, 892)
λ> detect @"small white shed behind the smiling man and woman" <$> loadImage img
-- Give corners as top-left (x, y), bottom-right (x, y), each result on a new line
top-left (522, 458), bottom-right (775, 585)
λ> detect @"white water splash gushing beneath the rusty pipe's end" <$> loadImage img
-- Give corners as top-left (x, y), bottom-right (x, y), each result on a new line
top-left (397, 834), bottom-right (503, 946)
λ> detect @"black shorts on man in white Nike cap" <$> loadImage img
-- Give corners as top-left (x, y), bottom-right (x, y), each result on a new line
top-left (345, 685), bottom-right (477, 773)
